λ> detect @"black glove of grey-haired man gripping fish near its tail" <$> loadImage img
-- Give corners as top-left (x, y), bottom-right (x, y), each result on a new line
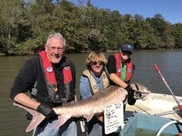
top-left (37, 104), bottom-right (57, 119)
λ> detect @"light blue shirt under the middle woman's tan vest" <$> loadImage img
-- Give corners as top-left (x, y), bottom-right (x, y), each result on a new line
top-left (80, 72), bottom-right (104, 99)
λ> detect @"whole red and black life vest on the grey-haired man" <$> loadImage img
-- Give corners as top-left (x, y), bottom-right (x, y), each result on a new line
top-left (39, 51), bottom-right (74, 103)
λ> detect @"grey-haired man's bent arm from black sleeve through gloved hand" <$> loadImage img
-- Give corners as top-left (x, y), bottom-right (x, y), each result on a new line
top-left (10, 60), bottom-right (57, 118)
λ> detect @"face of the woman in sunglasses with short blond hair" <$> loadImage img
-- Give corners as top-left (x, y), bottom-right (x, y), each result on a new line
top-left (90, 61), bottom-right (104, 76)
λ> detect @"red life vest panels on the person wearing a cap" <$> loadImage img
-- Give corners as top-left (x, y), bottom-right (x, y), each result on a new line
top-left (114, 52), bottom-right (133, 81)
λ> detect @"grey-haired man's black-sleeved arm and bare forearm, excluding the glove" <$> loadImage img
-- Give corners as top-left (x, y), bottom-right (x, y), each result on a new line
top-left (10, 59), bottom-right (40, 109)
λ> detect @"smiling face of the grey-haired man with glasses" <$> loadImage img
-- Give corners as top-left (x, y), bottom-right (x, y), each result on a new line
top-left (45, 37), bottom-right (65, 64)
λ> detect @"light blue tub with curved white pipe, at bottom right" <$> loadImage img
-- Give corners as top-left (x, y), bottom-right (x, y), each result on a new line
top-left (120, 113), bottom-right (182, 136)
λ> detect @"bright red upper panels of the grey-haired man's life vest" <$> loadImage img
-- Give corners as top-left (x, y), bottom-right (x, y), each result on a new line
top-left (39, 51), bottom-right (72, 86)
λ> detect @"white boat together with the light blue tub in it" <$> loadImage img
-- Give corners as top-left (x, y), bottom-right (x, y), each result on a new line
top-left (120, 93), bottom-right (182, 136)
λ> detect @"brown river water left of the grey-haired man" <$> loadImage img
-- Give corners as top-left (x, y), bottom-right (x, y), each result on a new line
top-left (0, 56), bottom-right (31, 136)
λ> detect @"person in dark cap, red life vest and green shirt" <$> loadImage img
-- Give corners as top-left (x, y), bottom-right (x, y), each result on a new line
top-left (107, 44), bottom-right (136, 105)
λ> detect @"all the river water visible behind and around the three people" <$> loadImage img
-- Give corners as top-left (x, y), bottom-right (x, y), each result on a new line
top-left (0, 50), bottom-right (182, 136)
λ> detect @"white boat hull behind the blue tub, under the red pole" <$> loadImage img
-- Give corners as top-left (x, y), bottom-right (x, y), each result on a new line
top-left (126, 93), bottom-right (182, 120)
